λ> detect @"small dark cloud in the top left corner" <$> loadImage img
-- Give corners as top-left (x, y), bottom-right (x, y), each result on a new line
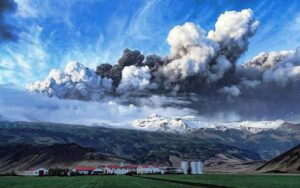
top-left (0, 0), bottom-right (18, 41)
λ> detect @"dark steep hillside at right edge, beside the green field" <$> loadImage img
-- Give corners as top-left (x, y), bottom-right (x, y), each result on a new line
top-left (257, 145), bottom-right (300, 173)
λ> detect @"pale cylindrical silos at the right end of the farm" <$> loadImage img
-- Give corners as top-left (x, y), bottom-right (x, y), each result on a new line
top-left (181, 160), bottom-right (203, 174)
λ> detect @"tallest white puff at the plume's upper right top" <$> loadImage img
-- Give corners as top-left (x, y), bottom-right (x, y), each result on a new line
top-left (208, 9), bottom-right (259, 61)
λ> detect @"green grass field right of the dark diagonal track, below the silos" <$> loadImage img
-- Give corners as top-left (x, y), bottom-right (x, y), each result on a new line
top-left (145, 174), bottom-right (300, 188)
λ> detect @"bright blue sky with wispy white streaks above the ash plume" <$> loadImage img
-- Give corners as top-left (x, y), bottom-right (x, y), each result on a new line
top-left (0, 0), bottom-right (300, 87)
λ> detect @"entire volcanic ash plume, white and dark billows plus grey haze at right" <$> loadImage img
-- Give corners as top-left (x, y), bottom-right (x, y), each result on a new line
top-left (23, 9), bottom-right (300, 119)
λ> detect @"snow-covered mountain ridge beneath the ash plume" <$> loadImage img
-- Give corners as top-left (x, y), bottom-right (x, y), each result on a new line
top-left (133, 114), bottom-right (285, 134)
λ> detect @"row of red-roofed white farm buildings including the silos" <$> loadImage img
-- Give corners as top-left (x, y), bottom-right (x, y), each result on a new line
top-left (24, 161), bottom-right (203, 176)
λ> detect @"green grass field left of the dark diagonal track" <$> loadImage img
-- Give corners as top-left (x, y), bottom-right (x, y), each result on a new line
top-left (0, 175), bottom-right (199, 188)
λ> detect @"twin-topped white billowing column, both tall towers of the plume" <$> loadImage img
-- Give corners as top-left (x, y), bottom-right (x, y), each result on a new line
top-left (162, 9), bottom-right (258, 81)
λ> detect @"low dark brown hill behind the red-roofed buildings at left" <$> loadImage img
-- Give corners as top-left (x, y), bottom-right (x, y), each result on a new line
top-left (0, 144), bottom-right (122, 173)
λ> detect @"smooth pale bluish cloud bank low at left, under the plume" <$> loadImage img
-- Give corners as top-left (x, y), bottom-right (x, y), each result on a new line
top-left (0, 85), bottom-right (193, 128)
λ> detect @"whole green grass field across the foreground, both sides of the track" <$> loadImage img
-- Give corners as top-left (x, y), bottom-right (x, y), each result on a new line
top-left (0, 174), bottom-right (300, 188)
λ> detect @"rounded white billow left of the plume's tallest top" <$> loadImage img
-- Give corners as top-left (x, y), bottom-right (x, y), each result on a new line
top-left (163, 22), bottom-right (218, 81)
